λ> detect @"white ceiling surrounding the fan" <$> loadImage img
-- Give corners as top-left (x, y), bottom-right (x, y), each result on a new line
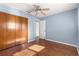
top-left (0, 3), bottom-right (78, 17)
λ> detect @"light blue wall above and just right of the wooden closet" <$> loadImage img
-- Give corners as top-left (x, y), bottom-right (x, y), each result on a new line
top-left (0, 5), bottom-right (38, 42)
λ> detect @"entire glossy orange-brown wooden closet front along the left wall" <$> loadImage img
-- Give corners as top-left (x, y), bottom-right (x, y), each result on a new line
top-left (0, 12), bottom-right (28, 50)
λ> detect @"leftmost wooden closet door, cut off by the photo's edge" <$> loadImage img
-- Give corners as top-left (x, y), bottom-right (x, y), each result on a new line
top-left (0, 12), bottom-right (7, 50)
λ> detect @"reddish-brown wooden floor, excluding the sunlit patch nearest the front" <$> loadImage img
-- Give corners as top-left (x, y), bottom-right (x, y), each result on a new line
top-left (0, 39), bottom-right (78, 56)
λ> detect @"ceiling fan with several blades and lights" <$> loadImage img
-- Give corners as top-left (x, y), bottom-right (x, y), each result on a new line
top-left (27, 4), bottom-right (50, 16)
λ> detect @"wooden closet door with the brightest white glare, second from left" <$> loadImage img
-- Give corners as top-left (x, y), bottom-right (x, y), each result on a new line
top-left (7, 14), bottom-right (16, 47)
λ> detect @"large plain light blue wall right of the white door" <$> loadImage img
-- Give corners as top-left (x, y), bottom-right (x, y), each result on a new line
top-left (43, 9), bottom-right (77, 45)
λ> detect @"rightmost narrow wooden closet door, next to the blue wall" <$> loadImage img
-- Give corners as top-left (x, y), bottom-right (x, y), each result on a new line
top-left (20, 17), bottom-right (28, 44)
